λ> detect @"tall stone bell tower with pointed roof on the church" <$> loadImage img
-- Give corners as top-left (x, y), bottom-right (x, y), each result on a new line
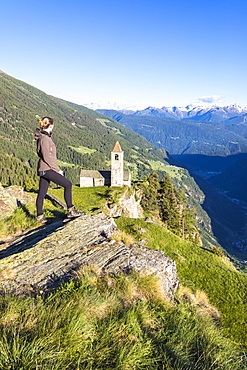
top-left (111, 141), bottom-right (124, 186)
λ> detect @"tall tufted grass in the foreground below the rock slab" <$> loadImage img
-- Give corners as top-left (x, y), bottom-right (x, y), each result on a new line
top-left (0, 269), bottom-right (244, 370)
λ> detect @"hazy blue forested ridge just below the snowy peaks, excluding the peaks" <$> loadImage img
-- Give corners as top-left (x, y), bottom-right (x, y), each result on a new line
top-left (97, 109), bottom-right (247, 156)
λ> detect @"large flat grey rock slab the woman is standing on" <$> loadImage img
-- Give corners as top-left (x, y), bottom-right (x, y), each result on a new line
top-left (0, 214), bottom-right (178, 297)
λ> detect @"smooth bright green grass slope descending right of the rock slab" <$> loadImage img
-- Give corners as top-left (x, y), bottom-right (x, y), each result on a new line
top-left (116, 217), bottom-right (247, 348)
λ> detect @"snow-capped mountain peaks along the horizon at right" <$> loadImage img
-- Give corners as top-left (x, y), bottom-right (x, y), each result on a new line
top-left (125, 104), bottom-right (247, 122)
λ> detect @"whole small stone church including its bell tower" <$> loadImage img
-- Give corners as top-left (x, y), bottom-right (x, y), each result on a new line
top-left (80, 141), bottom-right (131, 188)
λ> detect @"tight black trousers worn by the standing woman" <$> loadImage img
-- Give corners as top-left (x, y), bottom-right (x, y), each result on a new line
top-left (36, 170), bottom-right (73, 216)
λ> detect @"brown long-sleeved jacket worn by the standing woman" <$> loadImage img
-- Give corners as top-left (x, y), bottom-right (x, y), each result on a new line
top-left (34, 128), bottom-right (60, 176)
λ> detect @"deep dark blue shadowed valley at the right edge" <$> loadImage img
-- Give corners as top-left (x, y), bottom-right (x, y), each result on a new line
top-left (173, 153), bottom-right (247, 263)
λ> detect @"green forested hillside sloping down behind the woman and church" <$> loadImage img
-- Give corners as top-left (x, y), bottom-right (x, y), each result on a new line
top-left (0, 72), bottom-right (168, 184)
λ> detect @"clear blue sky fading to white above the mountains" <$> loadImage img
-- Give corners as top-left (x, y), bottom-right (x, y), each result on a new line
top-left (0, 0), bottom-right (247, 108)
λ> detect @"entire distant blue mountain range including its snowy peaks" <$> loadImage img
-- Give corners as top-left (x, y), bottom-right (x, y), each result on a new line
top-left (97, 105), bottom-right (247, 156)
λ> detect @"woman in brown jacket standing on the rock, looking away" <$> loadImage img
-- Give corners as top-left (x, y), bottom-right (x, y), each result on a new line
top-left (35, 117), bottom-right (85, 223)
